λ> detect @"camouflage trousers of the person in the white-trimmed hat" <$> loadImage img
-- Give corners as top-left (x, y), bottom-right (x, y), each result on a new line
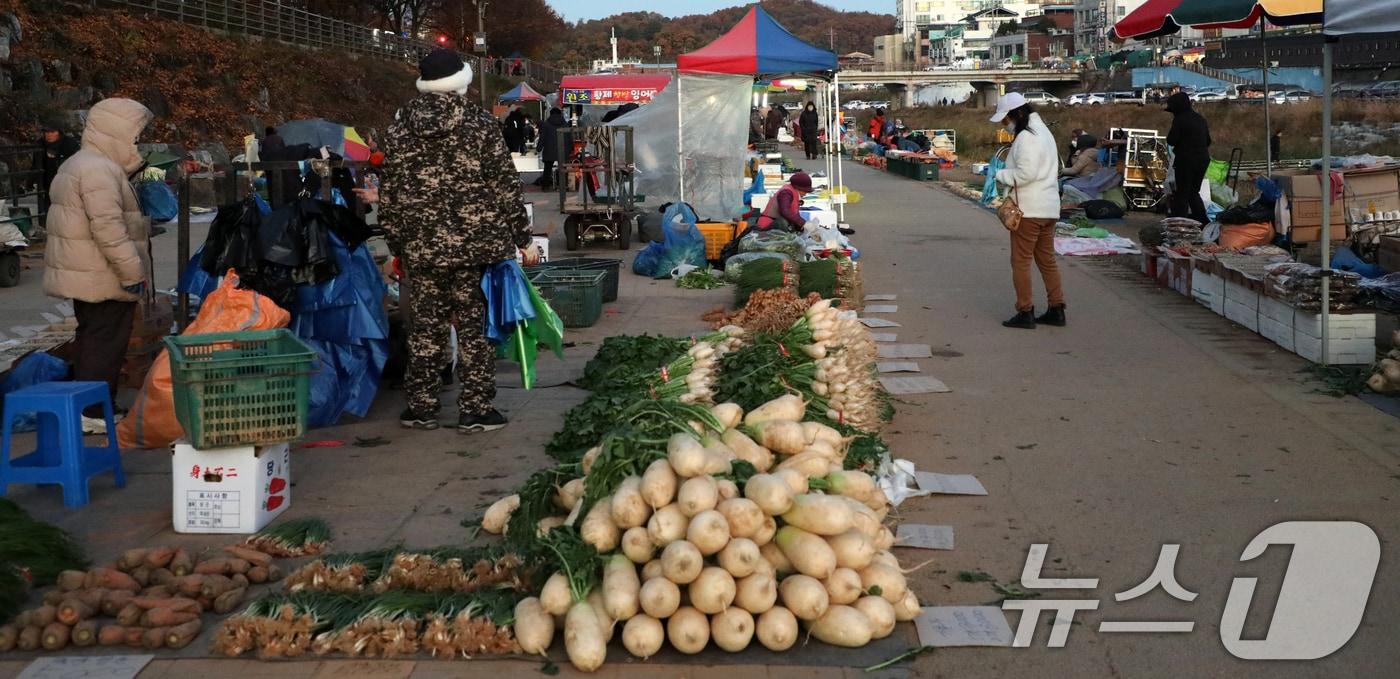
top-left (403, 266), bottom-right (496, 414)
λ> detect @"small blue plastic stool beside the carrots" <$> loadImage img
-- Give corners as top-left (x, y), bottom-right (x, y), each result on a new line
top-left (0, 382), bottom-right (126, 507)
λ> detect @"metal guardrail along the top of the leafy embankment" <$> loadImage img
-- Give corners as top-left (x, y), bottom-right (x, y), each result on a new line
top-left (81, 0), bottom-right (563, 85)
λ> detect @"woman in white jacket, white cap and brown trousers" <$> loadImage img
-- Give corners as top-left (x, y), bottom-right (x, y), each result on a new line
top-left (991, 92), bottom-right (1065, 330)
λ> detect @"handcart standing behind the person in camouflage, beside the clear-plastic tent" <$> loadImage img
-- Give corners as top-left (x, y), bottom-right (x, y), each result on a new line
top-left (554, 126), bottom-right (637, 251)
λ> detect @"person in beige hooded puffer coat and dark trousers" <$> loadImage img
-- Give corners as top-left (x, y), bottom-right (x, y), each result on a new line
top-left (43, 99), bottom-right (153, 433)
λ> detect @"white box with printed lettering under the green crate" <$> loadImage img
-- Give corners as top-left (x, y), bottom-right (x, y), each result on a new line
top-left (171, 442), bottom-right (291, 533)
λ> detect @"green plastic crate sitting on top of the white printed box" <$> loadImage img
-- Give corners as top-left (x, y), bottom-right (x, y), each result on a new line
top-left (165, 329), bottom-right (316, 448)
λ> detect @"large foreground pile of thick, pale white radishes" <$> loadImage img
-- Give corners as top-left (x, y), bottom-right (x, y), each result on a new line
top-left (491, 394), bottom-right (920, 672)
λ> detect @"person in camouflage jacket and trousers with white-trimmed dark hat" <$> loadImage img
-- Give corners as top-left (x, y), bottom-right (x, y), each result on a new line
top-left (375, 49), bottom-right (538, 433)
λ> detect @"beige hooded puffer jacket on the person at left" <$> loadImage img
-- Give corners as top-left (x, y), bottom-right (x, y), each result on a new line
top-left (43, 99), bottom-right (153, 302)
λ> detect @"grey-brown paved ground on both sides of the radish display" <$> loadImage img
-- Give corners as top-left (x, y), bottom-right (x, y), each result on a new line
top-left (0, 154), bottom-right (1400, 679)
